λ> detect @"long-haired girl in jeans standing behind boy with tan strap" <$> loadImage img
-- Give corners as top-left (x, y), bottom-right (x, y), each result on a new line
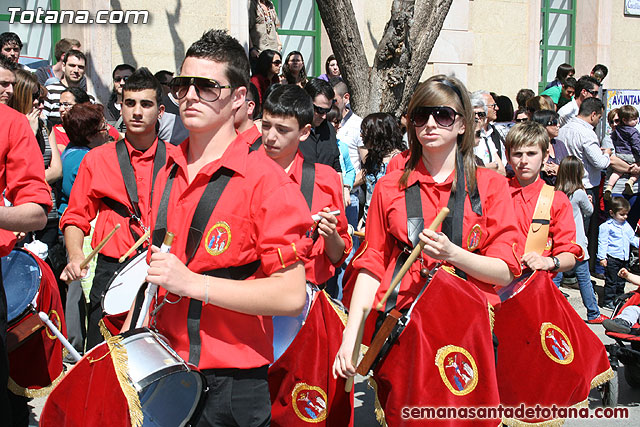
top-left (553, 156), bottom-right (606, 324)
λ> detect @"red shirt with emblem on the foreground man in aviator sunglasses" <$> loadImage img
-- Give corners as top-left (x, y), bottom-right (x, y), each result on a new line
top-left (153, 137), bottom-right (312, 369)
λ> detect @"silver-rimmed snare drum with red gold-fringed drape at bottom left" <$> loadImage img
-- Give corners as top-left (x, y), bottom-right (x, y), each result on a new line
top-left (40, 328), bottom-right (206, 427)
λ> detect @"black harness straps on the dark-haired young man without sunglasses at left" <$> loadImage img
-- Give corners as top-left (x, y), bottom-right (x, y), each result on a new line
top-left (102, 138), bottom-right (167, 247)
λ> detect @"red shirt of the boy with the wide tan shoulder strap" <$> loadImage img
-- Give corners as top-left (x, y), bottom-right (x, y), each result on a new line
top-left (509, 177), bottom-right (584, 260)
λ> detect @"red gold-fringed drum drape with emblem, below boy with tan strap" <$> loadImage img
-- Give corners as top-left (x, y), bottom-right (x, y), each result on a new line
top-left (494, 271), bottom-right (613, 425)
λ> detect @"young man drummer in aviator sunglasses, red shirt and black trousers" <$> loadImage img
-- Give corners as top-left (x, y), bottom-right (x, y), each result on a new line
top-left (140, 30), bottom-right (312, 426)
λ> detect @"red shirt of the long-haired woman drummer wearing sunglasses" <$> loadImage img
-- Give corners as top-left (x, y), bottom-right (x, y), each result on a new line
top-left (353, 161), bottom-right (521, 308)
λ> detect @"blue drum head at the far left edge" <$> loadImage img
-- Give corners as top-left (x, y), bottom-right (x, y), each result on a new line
top-left (2, 249), bottom-right (42, 323)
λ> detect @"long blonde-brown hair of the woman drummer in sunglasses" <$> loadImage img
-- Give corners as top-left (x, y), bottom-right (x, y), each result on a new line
top-left (399, 74), bottom-right (476, 192)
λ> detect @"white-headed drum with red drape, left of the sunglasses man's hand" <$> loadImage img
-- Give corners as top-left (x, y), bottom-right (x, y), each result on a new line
top-left (102, 251), bottom-right (149, 335)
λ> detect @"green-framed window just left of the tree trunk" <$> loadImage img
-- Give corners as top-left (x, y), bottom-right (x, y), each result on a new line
top-left (273, 0), bottom-right (324, 76)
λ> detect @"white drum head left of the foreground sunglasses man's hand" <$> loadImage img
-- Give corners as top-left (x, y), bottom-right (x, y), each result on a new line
top-left (102, 251), bottom-right (149, 314)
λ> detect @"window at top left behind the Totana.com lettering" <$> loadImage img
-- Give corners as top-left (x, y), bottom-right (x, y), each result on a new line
top-left (0, 0), bottom-right (60, 68)
